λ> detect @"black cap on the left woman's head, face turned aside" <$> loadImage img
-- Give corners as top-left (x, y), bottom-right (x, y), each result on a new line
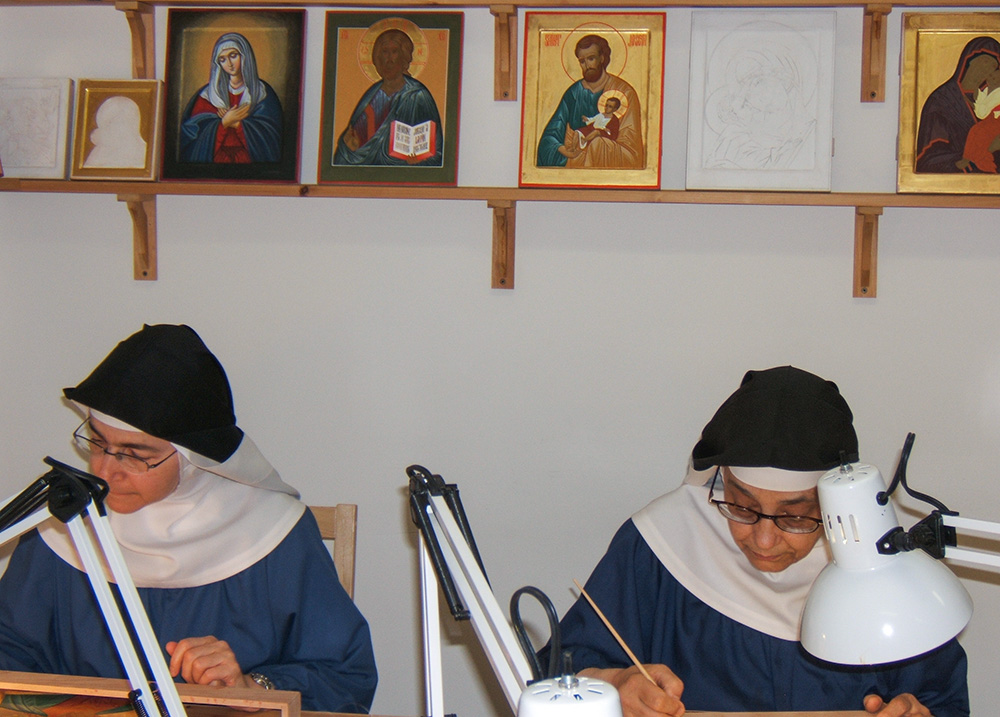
top-left (63, 324), bottom-right (243, 463)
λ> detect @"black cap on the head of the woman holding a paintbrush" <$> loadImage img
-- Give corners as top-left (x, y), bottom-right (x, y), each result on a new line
top-left (692, 366), bottom-right (858, 471)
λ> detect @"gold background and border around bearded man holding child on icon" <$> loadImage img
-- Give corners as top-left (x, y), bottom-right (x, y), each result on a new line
top-left (519, 12), bottom-right (666, 189)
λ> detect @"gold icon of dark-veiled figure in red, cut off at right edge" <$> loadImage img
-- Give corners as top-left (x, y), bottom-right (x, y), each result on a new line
top-left (897, 12), bottom-right (1000, 194)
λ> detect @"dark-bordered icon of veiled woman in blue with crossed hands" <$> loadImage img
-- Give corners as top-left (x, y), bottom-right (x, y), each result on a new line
top-left (162, 8), bottom-right (305, 182)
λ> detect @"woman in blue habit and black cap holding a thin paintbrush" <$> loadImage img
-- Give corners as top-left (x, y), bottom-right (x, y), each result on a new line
top-left (542, 366), bottom-right (969, 717)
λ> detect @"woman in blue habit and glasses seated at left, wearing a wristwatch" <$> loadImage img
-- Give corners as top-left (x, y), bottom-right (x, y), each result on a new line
top-left (0, 325), bottom-right (377, 714)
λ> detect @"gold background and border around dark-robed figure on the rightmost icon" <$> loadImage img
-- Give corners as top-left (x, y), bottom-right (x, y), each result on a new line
top-left (897, 12), bottom-right (1000, 194)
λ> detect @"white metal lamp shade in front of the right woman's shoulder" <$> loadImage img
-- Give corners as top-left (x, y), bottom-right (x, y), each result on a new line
top-left (801, 464), bottom-right (972, 665)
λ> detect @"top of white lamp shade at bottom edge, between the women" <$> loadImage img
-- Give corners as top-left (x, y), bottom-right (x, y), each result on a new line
top-left (517, 675), bottom-right (622, 717)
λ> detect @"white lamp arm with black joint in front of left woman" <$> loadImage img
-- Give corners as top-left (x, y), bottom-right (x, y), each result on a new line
top-left (0, 457), bottom-right (187, 717)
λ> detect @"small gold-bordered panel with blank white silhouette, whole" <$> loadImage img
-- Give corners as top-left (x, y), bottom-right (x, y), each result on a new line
top-left (69, 79), bottom-right (163, 180)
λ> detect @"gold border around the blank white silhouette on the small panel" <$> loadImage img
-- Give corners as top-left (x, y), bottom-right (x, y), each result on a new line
top-left (69, 80), bottom-right (163, 181)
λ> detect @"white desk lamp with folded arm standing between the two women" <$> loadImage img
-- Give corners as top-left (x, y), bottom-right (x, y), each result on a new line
top-left (406, 465), bottom-right (622, 717)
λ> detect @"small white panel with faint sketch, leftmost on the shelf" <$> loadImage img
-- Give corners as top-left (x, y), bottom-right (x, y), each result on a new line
top-left (0, 77), bottom-right (73, 179)
